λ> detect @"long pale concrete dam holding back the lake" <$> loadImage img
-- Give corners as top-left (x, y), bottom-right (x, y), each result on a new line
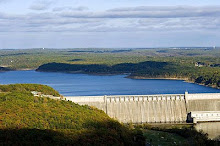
top-left (65, 92), bottom-right (220, 123)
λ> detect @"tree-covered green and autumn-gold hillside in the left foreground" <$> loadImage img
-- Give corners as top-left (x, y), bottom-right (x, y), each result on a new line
top-left (0, 84), bottom-right (144, 145)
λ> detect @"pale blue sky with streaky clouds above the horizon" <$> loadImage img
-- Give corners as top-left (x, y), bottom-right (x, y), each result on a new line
top-left (0, 0), bottom-right (220, 48)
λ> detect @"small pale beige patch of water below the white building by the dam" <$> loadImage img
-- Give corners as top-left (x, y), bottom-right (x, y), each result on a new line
top-left (195, 122), bottom-right (220, 139)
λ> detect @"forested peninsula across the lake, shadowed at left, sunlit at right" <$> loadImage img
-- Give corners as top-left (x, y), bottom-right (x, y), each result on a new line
top-left (37, 61), bottom-right (220, 88)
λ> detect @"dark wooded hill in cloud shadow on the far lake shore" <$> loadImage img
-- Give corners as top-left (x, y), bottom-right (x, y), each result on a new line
top-left (37, 61), bottom-right (168, 74)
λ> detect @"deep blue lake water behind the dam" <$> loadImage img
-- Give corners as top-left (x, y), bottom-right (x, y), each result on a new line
top-left (0, 71), bottom-right (220, 96)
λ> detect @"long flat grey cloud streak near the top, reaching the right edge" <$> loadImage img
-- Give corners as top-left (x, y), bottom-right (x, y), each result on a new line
top-left (61, 6), bottom-right (220, 18)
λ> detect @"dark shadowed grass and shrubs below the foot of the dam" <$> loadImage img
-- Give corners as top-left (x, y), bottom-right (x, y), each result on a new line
top-left (136, 124), bottom-right (220, 146)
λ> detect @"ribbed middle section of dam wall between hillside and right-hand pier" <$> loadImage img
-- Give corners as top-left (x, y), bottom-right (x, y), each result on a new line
top-left (107, 95), bottom-right (186, 123)
